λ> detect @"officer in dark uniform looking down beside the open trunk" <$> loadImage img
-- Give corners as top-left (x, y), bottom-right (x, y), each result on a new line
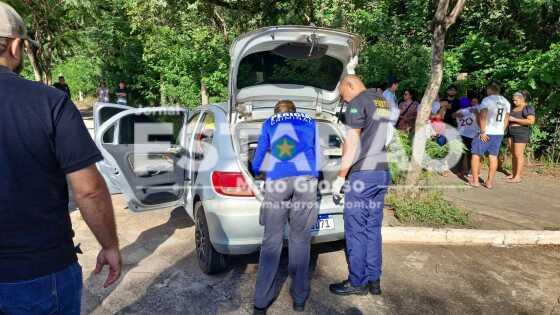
top-left (330, 76), bottom-right (397, 295)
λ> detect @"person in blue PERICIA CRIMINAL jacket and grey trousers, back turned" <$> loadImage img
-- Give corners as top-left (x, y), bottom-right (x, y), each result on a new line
top-left (252, 101), bottom-right (319, 314)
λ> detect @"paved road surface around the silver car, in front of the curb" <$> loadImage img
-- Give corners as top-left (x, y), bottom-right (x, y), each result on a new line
top-left (72, 196), bottom-right (560, 315)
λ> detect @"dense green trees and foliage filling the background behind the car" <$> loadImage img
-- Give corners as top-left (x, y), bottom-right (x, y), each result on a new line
top-left (8, 0), bottom-right (560, 161)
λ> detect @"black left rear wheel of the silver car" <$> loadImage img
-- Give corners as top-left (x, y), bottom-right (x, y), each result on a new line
top-left (195, 202), bottom-right (227, 275)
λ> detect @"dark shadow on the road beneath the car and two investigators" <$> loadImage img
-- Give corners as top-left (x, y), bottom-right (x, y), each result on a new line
top-left (115, 242), bottom-right (361, 314)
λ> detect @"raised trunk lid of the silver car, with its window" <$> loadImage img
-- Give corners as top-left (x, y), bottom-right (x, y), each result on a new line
top-left (229, 26), bottom-right (361, 113)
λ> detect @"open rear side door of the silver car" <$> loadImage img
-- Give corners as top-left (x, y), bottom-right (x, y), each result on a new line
top-left (95, 107), bottom-right (187, 212)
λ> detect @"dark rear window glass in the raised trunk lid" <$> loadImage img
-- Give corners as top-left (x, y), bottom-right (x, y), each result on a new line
top-left (237, 51), bottom-right (343, 91)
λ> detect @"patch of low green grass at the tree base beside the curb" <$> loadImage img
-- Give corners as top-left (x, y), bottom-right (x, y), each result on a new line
top-left (386, 189), bottom-right (471, 227)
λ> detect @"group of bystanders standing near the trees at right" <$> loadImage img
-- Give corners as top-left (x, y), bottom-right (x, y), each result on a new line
top-left (390, 77), bottom-right (536, 189)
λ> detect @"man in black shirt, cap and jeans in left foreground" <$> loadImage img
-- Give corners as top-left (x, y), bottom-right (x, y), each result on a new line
top-left (0, 2), bottom-right (121, 315)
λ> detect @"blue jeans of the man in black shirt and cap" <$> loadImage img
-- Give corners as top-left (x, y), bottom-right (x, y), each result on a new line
top-left (0, 263), bottom-right (82, 315)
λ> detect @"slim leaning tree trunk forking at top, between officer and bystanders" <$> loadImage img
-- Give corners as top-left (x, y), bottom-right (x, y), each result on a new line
top-left (406, 0), bottom-right (465, 189)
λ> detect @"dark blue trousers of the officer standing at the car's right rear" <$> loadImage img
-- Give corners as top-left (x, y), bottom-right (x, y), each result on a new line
top-left (343, 171), bottom-right (391, 287)
